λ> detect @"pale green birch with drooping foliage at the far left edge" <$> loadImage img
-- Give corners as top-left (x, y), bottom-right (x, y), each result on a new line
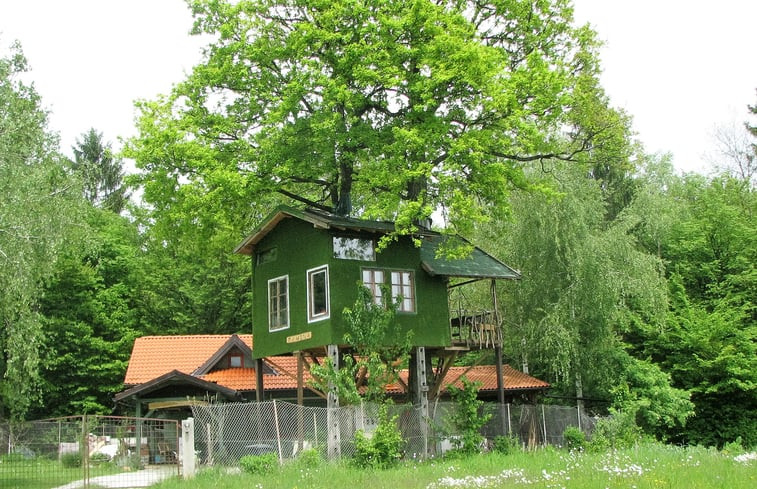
top-left (0, 45), bottom-right (85, 418)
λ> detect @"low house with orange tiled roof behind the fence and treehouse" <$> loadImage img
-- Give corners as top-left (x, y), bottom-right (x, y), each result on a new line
top-left (115, 334), bottom-right (549, 418)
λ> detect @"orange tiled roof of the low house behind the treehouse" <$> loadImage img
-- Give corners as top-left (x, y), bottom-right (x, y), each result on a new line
top-left (124, 335), bottom-right (549, 394)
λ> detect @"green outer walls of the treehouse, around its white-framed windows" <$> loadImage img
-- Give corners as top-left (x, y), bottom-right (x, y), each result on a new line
top-left (252, 218), bottom-right (451, 358)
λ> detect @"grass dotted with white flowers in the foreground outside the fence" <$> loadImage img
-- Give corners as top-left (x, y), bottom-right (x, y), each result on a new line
top-left (153, 444), bottom-right (757, 489)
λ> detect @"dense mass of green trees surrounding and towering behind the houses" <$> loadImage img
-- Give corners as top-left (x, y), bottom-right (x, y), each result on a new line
top-left (0, 0), bottom-right (757, 445)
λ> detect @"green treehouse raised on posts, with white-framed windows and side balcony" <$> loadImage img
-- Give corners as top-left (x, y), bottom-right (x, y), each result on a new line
top-left (236, 206), bottom-right (520, 407)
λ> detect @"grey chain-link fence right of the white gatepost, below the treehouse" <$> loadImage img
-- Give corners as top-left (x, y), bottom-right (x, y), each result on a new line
top-left (192, 401), bottom-right (594, 466)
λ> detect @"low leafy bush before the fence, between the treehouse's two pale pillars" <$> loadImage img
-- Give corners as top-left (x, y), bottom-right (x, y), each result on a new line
top-left (353, 404), bottom-right (405, 469)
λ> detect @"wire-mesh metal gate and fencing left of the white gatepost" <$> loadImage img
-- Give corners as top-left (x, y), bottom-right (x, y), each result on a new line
top-left (0, 415), bottom-right (180, 489)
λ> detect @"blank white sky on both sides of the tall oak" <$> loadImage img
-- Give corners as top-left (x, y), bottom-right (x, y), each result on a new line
top-left (0, 0), bottom-right (757, 172)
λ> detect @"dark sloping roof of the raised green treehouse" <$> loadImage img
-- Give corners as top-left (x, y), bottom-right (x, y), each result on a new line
top-left (234, 206), bottom-right (520, 279)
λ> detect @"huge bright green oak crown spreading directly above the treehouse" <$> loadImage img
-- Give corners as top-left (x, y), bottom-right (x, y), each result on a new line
top-left (127, 0), bottom-right (612, 240)
